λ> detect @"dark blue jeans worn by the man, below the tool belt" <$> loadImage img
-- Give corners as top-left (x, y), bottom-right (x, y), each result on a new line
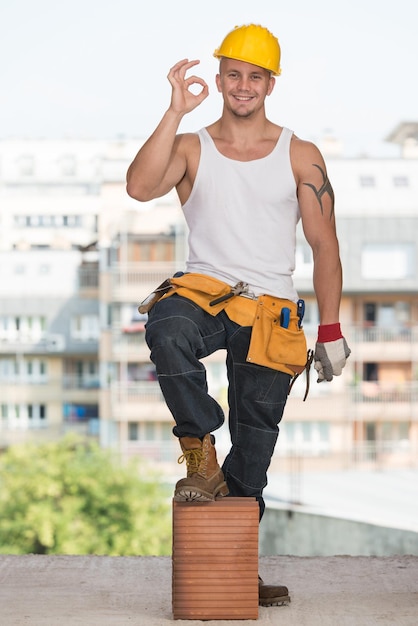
top-left (146, 295), bottom-right (290, 518)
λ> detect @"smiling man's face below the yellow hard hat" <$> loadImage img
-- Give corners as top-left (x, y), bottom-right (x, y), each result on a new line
top-left (216, 57), bottom-right (275, 117)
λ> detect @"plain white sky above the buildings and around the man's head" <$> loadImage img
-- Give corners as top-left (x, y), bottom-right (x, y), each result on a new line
top-left (0, 0), bottom-right (418, 156)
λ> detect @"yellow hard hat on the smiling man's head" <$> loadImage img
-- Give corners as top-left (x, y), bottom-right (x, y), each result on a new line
top-left (213, 24), bottom-right (281, 76)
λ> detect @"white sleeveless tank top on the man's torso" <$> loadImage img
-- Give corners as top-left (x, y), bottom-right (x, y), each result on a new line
top-left (182, 128), bottom-right (300, 301)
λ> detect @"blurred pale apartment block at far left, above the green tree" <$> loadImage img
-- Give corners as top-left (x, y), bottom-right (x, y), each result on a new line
top-left (0, 140), bottom-right (136, 447)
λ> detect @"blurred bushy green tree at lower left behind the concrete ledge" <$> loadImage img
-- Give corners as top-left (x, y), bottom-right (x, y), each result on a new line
top-left (0, 437), bottom-right (171, 556)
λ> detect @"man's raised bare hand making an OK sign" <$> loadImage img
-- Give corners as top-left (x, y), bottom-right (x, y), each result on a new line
top-left (167, 59), bottom-right (209, 114)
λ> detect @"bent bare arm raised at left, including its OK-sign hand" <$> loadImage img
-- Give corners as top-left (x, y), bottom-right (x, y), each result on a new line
top-left (126, 59), bottom-right (209, 201)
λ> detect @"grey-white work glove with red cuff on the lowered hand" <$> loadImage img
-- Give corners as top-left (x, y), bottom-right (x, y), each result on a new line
top-left (314, 324), bottom-right (351, 383)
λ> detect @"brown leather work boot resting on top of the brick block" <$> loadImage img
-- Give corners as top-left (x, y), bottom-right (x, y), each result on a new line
top-left (174, 434), bottom-right (229, 502)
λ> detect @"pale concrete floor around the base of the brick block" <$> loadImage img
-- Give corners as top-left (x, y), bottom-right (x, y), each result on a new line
top-left (0, 555), bottom-right (418, 626)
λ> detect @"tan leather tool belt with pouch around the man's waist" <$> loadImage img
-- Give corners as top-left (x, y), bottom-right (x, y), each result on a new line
top-left (138, 273), bottom-right (312, 398)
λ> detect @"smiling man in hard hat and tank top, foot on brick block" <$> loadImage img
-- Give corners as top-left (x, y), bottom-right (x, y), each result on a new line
top-left (127, 24), bottom-right (350, 605)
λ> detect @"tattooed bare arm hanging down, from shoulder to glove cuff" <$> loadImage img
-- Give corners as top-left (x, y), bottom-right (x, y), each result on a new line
top-left (292, 138), bottom-right (342, 325)
